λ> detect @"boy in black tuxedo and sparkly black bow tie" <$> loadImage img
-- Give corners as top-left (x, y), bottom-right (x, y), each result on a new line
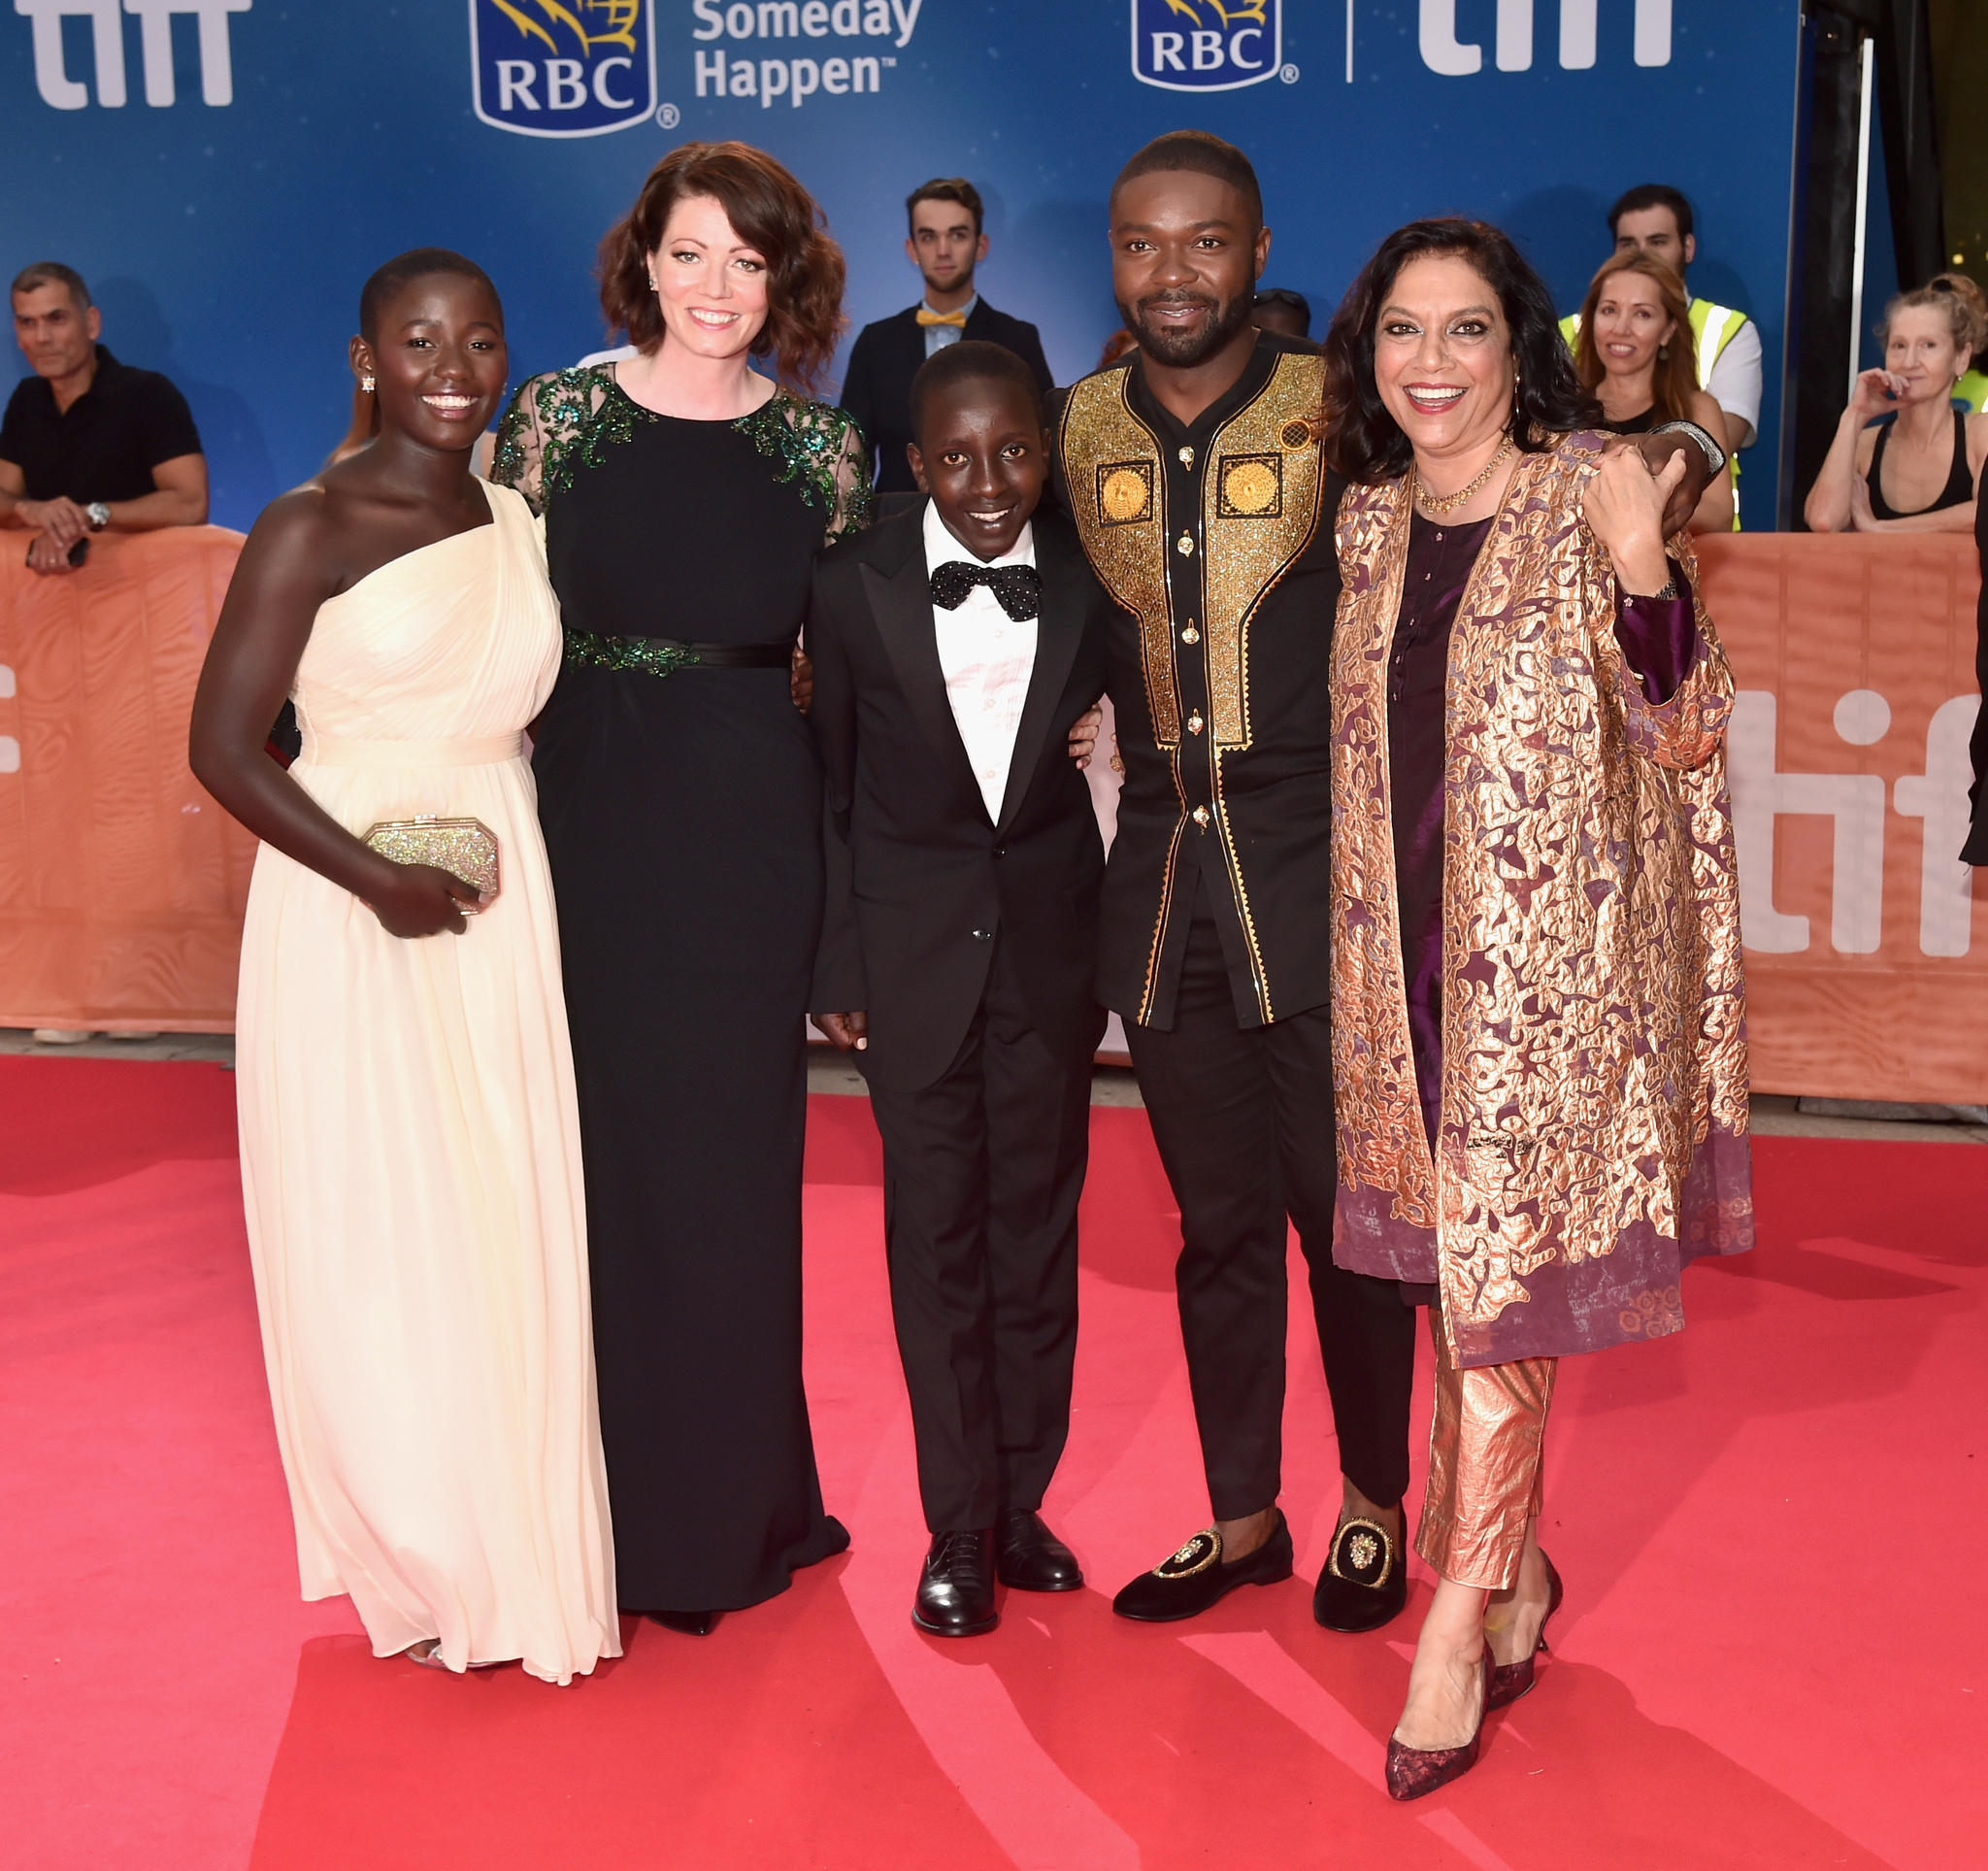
top-left (807, 340), bottom-right (1110, 1636)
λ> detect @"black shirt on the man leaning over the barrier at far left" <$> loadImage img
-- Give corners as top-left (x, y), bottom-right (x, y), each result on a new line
top-left (0, 344), bottom-right (201, 505)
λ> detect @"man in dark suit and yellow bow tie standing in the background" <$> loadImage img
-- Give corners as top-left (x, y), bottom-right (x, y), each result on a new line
top-left (843, 175), bottom-right (1053, 493)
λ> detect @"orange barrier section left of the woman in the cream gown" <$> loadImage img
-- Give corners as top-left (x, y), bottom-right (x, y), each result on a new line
top-left (0, 527), bottom-right (254, 1032)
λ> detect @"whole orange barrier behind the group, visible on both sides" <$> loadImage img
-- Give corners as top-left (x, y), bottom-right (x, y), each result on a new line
top-left (0, 527), bottom-right (1988, 1104)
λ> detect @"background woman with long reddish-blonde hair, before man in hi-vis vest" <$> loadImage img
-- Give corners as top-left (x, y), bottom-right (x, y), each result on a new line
top-left (1574, 252), bottom-right (1734, 533)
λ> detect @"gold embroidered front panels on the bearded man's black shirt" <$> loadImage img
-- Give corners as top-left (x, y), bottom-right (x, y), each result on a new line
top-left (1060, 351), bottom-right (1324, 759)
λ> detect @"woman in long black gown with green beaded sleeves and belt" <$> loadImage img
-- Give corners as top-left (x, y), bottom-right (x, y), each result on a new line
top-left (495, 143), bottom-right (869, 1634)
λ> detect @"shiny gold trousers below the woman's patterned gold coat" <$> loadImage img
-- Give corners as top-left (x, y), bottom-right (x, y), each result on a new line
top-left (1415, 1306), bottom-right (1561, 1590)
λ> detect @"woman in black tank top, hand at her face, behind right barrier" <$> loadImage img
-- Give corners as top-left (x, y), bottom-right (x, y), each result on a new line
top-left (1801, 273), bottom-right (1988, 533)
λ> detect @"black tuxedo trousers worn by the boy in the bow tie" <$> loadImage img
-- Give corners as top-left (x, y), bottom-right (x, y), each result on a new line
top-left (871, 937), bottom-right (1104, 1533)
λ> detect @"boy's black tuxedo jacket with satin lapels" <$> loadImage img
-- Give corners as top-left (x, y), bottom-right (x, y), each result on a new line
top-left (807, 501), bottom-right (1111, 1091)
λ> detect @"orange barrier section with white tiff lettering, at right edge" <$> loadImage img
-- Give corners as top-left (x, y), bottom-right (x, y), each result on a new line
top-left (1698, 533), bottom-right (1988, 1104)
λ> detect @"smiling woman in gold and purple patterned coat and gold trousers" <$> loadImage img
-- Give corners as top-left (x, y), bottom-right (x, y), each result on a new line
top-left (1326, 220), bottom-right (1751, 1799)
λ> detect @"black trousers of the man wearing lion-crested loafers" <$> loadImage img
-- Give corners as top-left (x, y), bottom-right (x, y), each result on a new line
top-left (1125, 909), bottom-right (1415, 1521)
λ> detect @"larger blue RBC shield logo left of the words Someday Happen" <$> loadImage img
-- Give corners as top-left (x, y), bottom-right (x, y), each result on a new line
top-left (469, 0), bottom-right (656, 137)
